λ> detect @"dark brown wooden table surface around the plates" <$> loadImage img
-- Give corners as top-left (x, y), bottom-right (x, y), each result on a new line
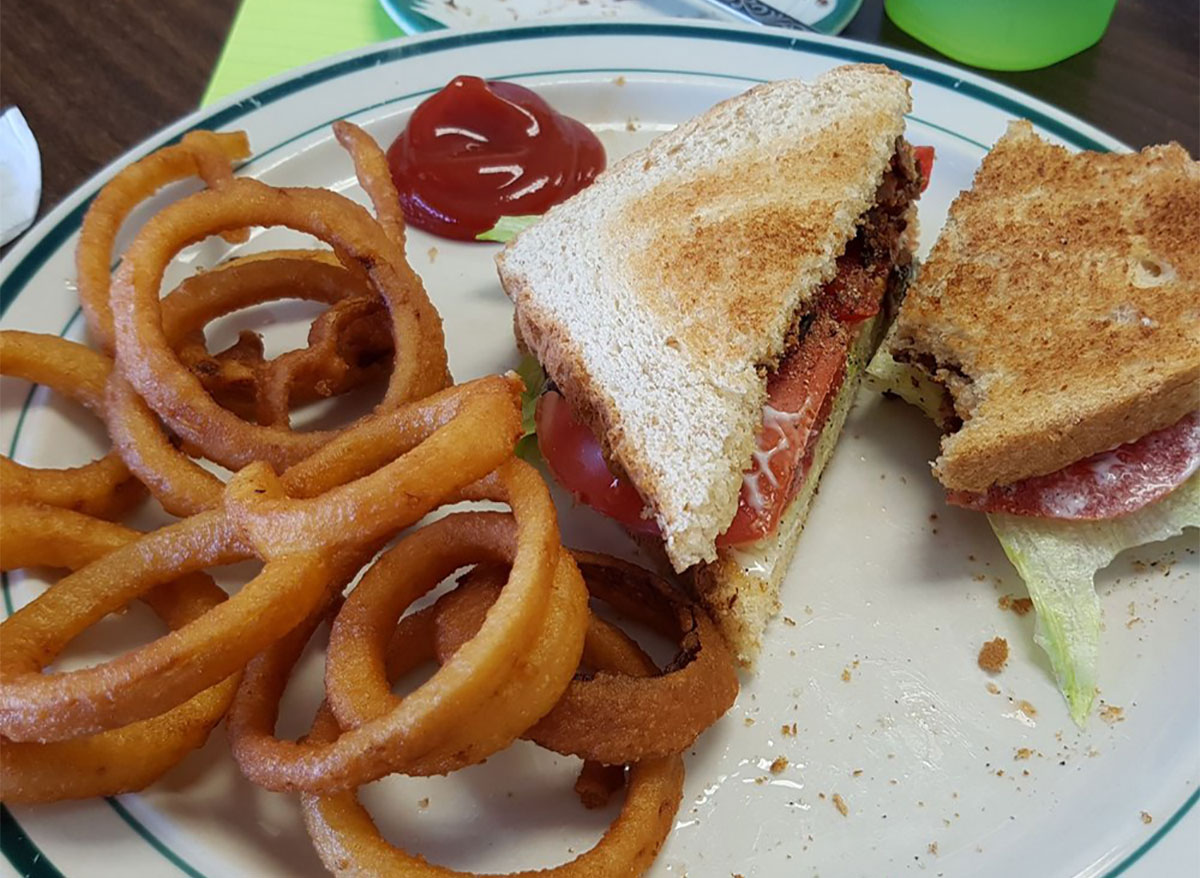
top-left (0, 0), bottom-right (1200, 226)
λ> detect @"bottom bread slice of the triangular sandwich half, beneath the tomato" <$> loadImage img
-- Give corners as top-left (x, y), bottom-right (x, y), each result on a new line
top-left (692, 304), bottom-right (888, 668)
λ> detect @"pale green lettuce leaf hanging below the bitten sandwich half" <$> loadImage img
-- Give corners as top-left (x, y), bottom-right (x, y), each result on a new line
top-left (988, 475), bottom-right (1200, 726)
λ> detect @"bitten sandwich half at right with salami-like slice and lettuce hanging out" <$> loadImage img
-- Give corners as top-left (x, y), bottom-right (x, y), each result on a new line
top-left (871, 121), bottom-right (1200, 722)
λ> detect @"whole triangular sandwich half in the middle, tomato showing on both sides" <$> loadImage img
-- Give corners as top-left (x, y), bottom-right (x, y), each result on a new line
top-left (497, 65), bottom-right (923, 664)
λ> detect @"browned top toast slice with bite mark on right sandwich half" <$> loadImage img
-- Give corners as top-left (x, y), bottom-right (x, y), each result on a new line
top-left (892, 122), bottom-right (1200, 492)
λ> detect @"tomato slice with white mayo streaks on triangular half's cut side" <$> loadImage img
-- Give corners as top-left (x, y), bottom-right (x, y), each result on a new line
top-left (716, 314), bottom-right (848, 547)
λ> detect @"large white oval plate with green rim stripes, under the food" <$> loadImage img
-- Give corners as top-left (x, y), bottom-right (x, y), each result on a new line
top-left (0, 22), bottom-right (1200, 877)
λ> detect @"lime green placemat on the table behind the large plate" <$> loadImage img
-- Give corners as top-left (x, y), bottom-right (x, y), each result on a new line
top-left (200, 0), bottom-right (402, 106)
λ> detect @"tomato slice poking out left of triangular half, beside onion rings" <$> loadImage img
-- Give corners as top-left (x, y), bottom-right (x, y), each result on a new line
top-left (535, 390), bottom-right (659, 534)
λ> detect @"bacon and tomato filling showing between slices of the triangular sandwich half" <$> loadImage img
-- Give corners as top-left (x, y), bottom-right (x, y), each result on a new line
top-left (538, 138), bottom-right (931, 547)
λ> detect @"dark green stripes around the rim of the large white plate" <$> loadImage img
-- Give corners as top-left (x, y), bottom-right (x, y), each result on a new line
top-left (0, 22), bottom-right (1176, 878)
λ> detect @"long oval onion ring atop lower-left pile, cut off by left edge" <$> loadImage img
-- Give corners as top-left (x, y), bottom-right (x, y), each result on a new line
top-left (0, 512), bottom-right (335, 741)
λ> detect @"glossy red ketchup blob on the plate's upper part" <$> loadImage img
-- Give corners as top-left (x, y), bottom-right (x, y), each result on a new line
top-left (388, 77), bottom-right (605, 241)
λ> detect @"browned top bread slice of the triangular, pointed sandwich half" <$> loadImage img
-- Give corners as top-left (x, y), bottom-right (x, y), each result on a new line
top-left (497, 65), bottom-right (910, 570)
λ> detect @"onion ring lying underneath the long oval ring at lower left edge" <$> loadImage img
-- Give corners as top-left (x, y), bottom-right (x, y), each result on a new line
top-left (0, 504), bottom-right (240, 804)
